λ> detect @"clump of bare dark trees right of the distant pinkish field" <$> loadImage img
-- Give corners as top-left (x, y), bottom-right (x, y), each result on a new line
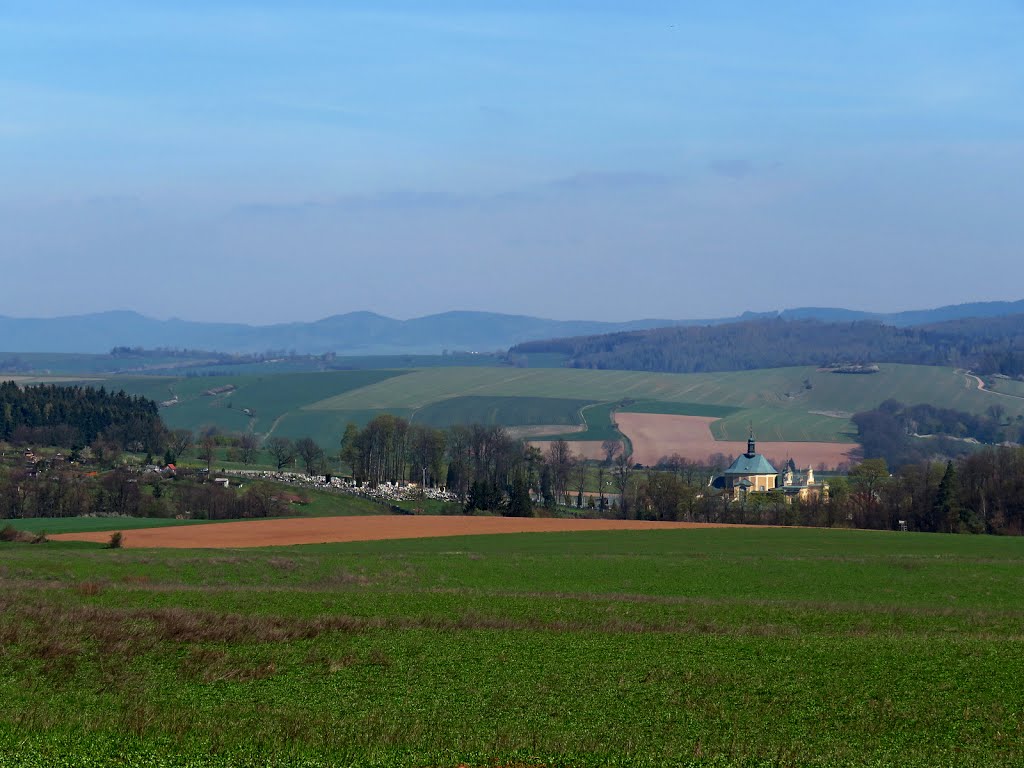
top-left (852, 399), bottom-right (1024, 466)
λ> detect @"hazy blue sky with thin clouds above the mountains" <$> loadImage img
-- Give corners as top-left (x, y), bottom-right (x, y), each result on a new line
top-left (0, 0), bottom-right (1024, 323)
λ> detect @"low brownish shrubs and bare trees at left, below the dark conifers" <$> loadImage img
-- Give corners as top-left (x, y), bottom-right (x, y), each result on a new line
top-left (0, 468), bottom-right (288, 520)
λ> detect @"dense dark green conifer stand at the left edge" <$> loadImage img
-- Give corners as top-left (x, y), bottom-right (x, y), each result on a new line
top-left (0, 381), bottom-right (166, 452)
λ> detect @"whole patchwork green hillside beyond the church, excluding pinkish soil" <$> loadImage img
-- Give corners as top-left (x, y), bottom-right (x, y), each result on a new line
top-left (110, 365), bottom-right (1024, 464)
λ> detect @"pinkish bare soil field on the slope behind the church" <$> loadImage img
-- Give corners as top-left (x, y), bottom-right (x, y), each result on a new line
top-left (615, 414), bottom-right (857, 469)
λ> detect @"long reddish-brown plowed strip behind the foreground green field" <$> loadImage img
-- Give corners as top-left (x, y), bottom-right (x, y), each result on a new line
top-left (49, 515), bottom-right (745, 549)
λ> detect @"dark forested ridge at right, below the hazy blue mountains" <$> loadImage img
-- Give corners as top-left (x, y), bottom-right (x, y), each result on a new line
top-left (509, 314), bottom-right (1024, 376)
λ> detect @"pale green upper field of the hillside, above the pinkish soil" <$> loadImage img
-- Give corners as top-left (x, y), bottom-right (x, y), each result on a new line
top-left (306, 365), bottom-right (1024, 442)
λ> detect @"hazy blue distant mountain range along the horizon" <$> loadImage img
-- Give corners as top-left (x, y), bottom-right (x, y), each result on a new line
top-left (0, 300), bottom-right (1024, 354)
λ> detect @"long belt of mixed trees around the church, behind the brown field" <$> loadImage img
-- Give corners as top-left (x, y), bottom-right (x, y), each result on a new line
top-left (159, 417), bottom-right (1024, 534)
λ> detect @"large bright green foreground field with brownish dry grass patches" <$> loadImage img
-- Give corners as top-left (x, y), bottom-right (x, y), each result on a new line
top-left (0, 529), bottom-right (1024, 768)
